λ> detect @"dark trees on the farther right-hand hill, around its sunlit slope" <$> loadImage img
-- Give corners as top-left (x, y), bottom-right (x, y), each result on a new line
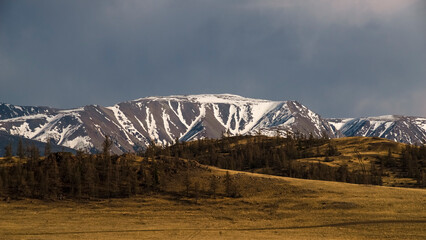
top-left (162, 134), bottom-right (426, 187)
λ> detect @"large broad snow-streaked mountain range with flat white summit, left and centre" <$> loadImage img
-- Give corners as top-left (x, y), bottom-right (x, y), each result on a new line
top-left (0, 94), bottom-right (340, 153)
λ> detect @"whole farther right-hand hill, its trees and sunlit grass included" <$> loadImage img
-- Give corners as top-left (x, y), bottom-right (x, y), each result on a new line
top-left (163, 136), bottom-right (426, 187)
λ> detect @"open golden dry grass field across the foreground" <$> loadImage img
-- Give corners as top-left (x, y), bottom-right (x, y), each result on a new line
top-left (0, 165), bottom-right (426, 239)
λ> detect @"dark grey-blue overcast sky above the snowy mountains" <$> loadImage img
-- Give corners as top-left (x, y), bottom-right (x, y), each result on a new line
top-left (0, 0), bottom-right (426, 117)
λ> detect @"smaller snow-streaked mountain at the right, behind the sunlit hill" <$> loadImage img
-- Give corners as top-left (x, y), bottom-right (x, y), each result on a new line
top-left (328, 115), bottom-right (426, 144)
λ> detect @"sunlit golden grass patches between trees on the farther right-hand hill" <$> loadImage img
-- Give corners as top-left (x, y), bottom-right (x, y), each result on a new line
top-left (183, 136), bottom-right (426, 187)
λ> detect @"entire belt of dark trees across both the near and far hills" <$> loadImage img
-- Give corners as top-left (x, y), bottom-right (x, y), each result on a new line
top-left (0, 135), bottom-right (426, 199)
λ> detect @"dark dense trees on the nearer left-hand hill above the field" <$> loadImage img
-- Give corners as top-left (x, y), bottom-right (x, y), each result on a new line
top-left (0, 137), bottom-right (239, 199)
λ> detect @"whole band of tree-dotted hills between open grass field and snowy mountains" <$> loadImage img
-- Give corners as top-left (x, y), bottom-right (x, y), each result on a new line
top-left (0, 136), bottom-right (426, 202)
